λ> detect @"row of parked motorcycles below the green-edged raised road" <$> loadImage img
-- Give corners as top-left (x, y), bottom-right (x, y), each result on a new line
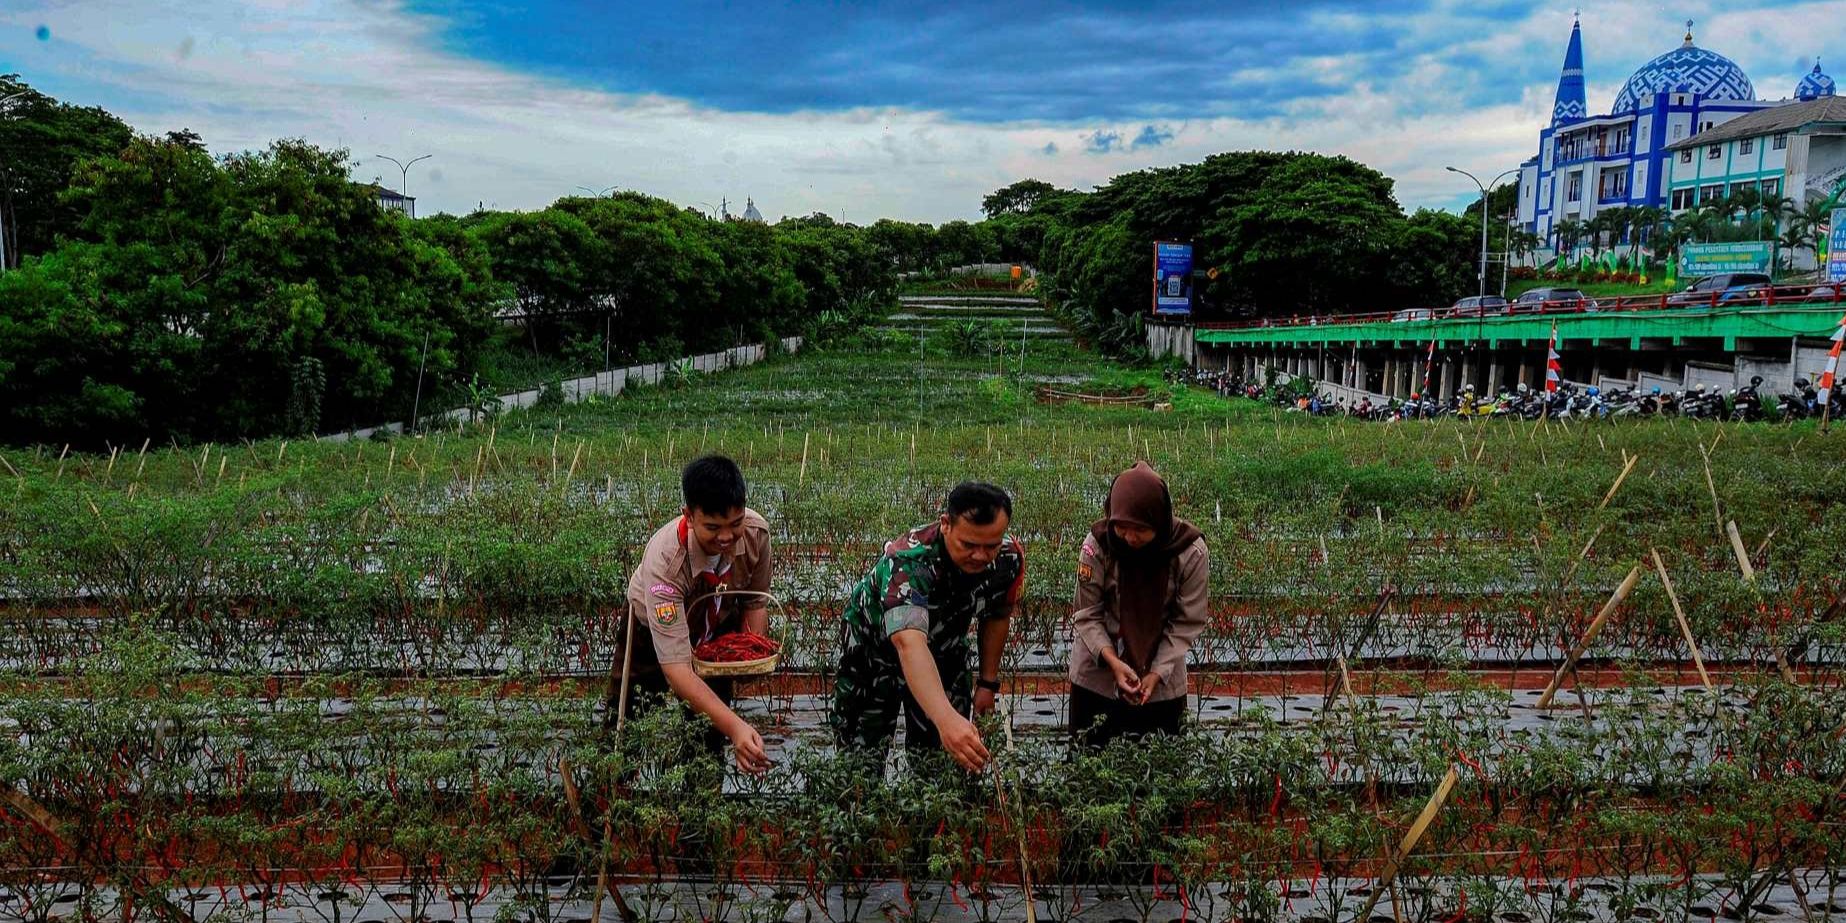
top-left (1178, 369), bottom-right (1846, 423)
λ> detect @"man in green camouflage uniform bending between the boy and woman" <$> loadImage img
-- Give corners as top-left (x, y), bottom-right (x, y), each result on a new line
top-left (829, 482), bottom-right (1026, 772)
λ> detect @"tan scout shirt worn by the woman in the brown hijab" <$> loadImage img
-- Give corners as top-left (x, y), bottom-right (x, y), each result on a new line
top-left (1071, 535), bottom-right (1211, 701)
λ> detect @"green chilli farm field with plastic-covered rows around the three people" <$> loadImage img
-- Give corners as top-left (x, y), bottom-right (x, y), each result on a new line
top-left (0, 342), bottom-right (1846, 923)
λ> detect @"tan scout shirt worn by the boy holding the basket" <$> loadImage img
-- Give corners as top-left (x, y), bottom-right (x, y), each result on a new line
top-left (617, 509), bottom-right (770, 672)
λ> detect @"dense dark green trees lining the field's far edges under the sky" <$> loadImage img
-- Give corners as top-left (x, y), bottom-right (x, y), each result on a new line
top-left (0, 78), bottom-right (1497, 447)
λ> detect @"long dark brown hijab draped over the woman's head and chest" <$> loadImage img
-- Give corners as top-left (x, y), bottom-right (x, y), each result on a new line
top-left (1089, 462), bottom-right (1200, 674)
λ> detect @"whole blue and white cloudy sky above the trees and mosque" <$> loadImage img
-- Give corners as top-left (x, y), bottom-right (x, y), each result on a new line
top-left (0, 0), bottom-right (1846, 223)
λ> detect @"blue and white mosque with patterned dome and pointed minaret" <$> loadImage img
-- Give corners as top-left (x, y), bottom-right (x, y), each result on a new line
top-left (1519, 22), bottom-right (1794, 253)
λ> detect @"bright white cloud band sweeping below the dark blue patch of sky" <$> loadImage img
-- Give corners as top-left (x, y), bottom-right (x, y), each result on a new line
top-left (0, 0), bottom-right (1846, 222)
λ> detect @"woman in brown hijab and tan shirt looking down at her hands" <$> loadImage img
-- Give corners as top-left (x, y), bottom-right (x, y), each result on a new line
top-left (1071, 462), bottom-right (1209, 748)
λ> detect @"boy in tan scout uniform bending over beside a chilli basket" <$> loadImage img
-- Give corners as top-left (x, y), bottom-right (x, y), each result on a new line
top-left (609, 456), bottom-right (770, 773)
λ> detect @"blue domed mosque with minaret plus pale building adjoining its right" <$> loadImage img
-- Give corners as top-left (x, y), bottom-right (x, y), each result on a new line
top-left (1519, 22), bottom-right (1846, 258)
